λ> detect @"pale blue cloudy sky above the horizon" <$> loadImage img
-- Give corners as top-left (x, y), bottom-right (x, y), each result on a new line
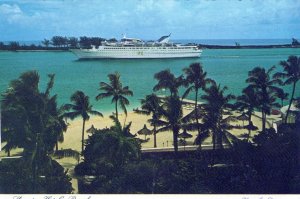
top-left (0, 0), bottom-right (300, 40)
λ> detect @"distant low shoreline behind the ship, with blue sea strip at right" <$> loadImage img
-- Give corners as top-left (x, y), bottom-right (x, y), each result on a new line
top-left (0, 36), bottom-right (300, 52)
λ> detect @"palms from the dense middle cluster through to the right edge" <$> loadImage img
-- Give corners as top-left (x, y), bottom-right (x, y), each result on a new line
top-left (135, 56), bottom-right (300, 156)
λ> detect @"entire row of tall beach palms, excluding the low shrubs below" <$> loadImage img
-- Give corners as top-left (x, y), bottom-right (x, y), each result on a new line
top-left (2, 56), bottom-right (300, 159)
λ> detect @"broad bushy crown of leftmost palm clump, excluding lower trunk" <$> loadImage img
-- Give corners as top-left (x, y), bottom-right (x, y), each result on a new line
top-left (1, 71), bottom-right (66, 155)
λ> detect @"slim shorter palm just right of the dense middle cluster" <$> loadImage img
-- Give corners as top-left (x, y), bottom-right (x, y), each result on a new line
top-left (235, 87), bottom-right (259, 140)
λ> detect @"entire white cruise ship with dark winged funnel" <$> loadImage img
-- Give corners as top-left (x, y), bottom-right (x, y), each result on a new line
top-left (71, 34), bottom-right (202, 59)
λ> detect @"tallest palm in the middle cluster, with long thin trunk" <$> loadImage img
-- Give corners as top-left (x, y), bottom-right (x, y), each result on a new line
top-left (183, 63), bottom-right (212, 141)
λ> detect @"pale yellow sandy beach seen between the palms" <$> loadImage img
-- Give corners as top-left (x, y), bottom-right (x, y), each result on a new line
top-left (0, 109), bottom-right (280, 157)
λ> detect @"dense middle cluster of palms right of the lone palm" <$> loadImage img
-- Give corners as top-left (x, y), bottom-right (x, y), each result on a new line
top-left (135, 63), bottom-right (239, 154)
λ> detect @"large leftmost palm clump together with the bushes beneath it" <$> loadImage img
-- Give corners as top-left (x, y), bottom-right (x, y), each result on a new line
top-left (1, 71), bottom-right (72, 193)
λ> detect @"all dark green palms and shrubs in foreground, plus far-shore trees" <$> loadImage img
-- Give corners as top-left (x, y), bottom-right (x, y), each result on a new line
top-left (0, 55), bottom-right (300, 194)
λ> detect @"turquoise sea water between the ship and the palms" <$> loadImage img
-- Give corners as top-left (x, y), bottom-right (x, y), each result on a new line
top-left (0, 39), bottom-right (300, 114)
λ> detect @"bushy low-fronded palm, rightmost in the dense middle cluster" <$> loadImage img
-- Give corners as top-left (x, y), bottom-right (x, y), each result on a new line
top-left (201, 82), bottom-right (236, 150)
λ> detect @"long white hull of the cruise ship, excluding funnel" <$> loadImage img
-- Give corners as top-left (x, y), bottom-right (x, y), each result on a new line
top-left (71, 46), bottom-right (202, 59)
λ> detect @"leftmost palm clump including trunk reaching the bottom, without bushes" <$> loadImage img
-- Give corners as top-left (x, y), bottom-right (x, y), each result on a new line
top-left (1, 71), bottom-right (71, 193)
